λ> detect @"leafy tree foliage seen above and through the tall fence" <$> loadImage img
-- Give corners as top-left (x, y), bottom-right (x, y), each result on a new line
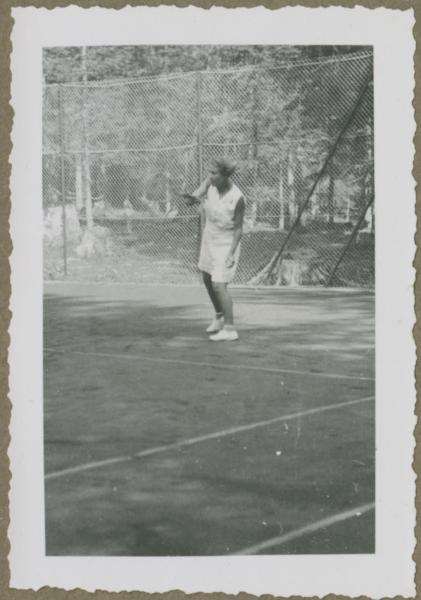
top-left (44, 46), bottom-right (372, 229)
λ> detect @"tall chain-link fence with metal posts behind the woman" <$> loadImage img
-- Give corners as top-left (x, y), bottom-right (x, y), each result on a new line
top-left (43, 52), bottom-right (374, 286)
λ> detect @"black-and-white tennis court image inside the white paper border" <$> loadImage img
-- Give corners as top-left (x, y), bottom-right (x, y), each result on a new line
top-left (8, 9), bottom-right (412, 594)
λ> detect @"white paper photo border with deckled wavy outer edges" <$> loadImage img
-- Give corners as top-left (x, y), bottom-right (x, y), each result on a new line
top-left (9, 6), bottom-right (416, 598)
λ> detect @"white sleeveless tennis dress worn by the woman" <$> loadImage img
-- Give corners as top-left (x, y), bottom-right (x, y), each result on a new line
top-left (199, 184), bottom-right (243, 283)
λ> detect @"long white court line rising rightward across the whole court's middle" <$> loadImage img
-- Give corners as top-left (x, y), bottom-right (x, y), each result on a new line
top-left (45, 396), bottom-right (374, 479)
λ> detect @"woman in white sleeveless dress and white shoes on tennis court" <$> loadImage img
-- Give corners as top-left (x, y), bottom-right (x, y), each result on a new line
top-left (191, 160), bottom-right (245, 342)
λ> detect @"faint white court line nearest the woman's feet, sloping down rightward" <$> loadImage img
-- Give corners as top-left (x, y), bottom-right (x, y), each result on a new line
top-left (44, 347), bottom-right (374, 381)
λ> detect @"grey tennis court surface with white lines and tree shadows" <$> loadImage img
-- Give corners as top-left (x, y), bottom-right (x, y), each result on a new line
top-left (44, 283), bottom-right (375, 556)
